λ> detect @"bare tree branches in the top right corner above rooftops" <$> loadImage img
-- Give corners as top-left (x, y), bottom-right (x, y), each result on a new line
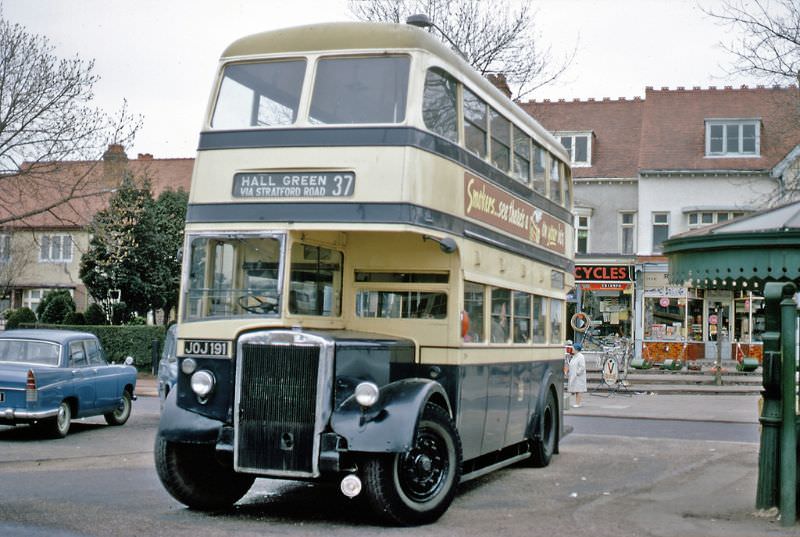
top-left (705, 0), bottom-right (800, 84)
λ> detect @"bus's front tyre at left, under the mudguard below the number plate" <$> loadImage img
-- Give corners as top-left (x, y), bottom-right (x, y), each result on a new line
top-left (155, 435), bottom-right (255, 511)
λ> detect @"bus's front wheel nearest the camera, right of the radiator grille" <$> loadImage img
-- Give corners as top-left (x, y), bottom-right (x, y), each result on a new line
top-left (363, 405), bottom-right (461, 525)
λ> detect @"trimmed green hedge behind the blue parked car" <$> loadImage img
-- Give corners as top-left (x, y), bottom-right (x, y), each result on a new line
top-left (20, 323), bottom-right (167, 371)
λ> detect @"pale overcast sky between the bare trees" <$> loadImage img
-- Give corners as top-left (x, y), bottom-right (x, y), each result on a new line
top-left (0, 0), bottom-right (758, 158)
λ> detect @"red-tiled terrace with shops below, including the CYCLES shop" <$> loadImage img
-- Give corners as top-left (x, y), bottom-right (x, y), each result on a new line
top-left (523, 86), bottom-right (800, 361)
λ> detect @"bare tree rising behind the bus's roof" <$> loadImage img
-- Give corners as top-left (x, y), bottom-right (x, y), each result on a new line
top-left (348, 0), bottom-right (575, 99)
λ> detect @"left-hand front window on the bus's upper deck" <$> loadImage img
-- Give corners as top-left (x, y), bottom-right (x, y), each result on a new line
top-left (211, 60), bottom-right (306, 129)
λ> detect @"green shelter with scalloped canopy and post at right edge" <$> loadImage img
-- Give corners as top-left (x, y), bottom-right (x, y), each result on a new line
top-left (664, 202), bottom-right (800, 526)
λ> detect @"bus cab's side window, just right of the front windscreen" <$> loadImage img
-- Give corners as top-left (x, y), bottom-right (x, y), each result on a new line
top-left (289, 243), bottom-right (342, 317)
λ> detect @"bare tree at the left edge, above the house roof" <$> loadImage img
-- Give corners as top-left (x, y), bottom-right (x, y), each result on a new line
top-left (0, 10), bottom-right (141, 224)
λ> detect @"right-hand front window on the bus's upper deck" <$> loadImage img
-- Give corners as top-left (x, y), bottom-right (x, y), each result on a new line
top-left (309, 56), bottom-right (410, 124)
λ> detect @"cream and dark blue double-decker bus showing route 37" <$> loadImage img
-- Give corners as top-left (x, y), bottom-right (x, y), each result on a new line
top-left (155, 19), bottom-right (574, 524)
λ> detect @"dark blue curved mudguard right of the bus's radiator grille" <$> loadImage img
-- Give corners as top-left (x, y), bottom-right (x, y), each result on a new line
top-left (331, 378), bottom-right (452, 453)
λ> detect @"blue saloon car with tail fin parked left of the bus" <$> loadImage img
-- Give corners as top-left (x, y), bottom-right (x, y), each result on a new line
top-left (0, 329), bottom-right (136, 438)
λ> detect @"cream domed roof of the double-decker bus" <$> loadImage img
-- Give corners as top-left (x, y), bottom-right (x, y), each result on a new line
top-left (221, 22), bottom-right (569, 162)
